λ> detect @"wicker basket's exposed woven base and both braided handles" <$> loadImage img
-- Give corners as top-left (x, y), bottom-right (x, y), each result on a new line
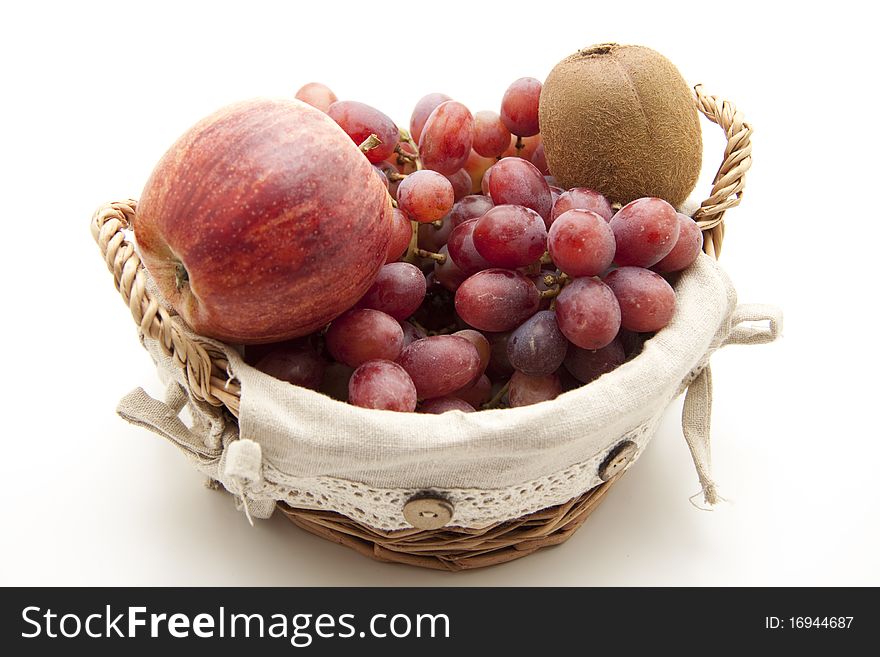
top-left (91, 86), bottom-right (752, 570)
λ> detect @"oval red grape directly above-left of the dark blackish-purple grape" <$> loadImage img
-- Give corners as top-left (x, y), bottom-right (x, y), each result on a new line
top-left (455, 268), bottom-right (540, 331)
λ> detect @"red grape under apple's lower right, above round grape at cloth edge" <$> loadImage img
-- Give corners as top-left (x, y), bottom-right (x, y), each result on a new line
top-left (324, 308), bottom-right (403, 367)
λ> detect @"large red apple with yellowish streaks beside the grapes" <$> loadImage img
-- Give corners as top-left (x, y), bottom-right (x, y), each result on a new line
top-left (133, 100), bottom-right (391, 344)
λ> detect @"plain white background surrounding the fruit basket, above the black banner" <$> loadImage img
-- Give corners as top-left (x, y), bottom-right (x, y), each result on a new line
top-left (0, 0), bottom-right (880, 585)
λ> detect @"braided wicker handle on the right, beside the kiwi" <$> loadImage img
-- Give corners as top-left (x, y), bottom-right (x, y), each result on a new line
top-left (693, 84), bottom-right (752, 258)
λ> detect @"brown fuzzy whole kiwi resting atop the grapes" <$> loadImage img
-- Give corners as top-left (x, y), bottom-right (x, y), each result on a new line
top-left (539, 44), bottom-right (703, 207)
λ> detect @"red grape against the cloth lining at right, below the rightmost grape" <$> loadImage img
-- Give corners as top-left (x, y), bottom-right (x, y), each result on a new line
top-left (605, 267), bottom-right (675, 333)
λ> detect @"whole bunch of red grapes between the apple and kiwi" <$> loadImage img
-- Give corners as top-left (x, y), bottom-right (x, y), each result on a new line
top-left (246, 78), bottom-right (702, 413)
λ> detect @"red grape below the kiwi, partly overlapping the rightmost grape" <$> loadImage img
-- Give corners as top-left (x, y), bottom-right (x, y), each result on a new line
top-left (611, 197), bottom-right (680, 267)
